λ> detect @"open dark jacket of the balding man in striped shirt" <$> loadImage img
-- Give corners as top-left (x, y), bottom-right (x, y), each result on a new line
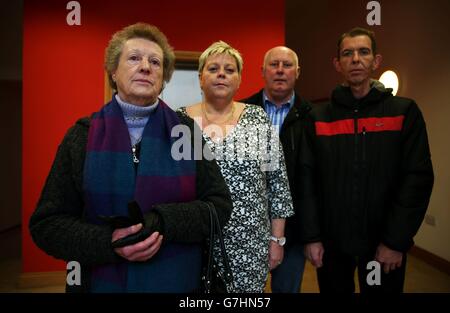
top-left (240, 89), bottom-right (311, 245)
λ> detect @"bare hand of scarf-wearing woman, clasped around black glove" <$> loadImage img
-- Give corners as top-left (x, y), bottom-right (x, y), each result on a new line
top-left (111, 224), bottom-right (163, 262)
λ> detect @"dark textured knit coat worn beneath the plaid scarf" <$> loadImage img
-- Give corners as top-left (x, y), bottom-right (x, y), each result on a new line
top-left (29, 114), bottom-right (232, 292)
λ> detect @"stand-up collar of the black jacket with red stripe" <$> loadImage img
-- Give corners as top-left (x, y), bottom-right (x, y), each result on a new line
top-left (331, 80), bottom-right (392, 109)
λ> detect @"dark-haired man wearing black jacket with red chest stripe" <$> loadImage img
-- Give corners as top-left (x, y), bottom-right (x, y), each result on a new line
top-left (299, 28), bottom-right (434, 293)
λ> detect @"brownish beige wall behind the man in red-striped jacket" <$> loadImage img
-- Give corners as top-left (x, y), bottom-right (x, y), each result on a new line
top-left (286, 0), bottom-right (450, 261)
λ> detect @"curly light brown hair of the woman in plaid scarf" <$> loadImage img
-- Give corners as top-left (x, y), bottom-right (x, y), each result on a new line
top-left (105, 23), bottom-right (175, 90)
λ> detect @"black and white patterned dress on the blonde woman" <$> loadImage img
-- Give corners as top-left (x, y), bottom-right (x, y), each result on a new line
top-left (180, 104), bottom-right (294, 292)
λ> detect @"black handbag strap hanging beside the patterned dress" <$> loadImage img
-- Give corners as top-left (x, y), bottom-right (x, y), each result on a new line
top-left (206, 202), bottom-right (233, 292)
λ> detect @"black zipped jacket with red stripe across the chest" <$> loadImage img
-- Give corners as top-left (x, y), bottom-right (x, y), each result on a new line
top-left (300, 84), bottom-right (434, 255)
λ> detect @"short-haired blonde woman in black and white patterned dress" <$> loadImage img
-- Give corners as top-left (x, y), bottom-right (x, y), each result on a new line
top-left (180, 41), bottom-right (293, 292)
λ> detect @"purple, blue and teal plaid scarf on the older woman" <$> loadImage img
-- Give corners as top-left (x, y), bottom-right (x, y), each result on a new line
top-left (83, 97), bottom-right (201, 292)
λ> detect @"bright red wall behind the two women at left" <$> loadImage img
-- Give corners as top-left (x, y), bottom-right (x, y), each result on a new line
top-left (22, 0), bottom-right (284, 272)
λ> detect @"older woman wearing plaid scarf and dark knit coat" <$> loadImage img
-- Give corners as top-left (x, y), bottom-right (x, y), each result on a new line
top-left (30, 23), bottom-right (232, 292)
